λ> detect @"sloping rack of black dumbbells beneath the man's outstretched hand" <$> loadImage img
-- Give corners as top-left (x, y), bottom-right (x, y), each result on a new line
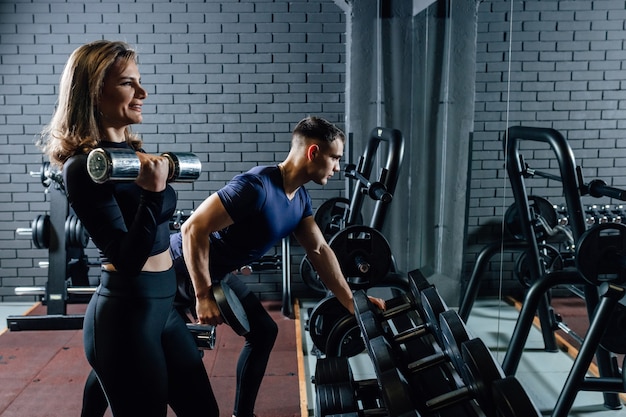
top-left (313, 270), bottom-right (541, 417)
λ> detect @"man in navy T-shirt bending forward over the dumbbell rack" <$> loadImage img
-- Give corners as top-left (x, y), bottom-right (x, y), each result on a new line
top-left (181, 117), bottom-right (384, 417)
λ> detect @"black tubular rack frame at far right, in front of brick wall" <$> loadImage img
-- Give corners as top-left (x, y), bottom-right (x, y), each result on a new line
top-left (492, 126), bottom-right (624, 417)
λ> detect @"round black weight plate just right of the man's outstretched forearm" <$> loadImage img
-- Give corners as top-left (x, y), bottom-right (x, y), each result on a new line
top-left (329, 225), bottom-right (392, 289)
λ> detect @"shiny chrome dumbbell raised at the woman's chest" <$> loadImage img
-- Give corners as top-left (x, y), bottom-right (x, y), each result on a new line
top-left (87, 148), bottom-right (202, 184)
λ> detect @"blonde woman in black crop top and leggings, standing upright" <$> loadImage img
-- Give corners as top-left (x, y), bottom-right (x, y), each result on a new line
top-left (40, 41), bottom-right (219, 417)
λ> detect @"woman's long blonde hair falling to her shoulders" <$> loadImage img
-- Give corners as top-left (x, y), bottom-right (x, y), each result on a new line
top-left (37, 40), bottom-right (142, 165)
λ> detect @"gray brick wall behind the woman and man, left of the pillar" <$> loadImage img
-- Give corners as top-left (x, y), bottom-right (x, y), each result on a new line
top-left (0, 0), bottom-right (346, 301)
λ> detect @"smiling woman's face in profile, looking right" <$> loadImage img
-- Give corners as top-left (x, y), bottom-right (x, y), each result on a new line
top-left (99, 59), bottom-right (148, 130)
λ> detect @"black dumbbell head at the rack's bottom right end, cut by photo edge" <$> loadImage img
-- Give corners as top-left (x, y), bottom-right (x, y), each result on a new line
top-left (491, 375), bottom-right (542, 417)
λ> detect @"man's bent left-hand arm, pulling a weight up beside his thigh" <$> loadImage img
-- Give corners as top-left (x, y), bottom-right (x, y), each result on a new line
top-left (180, 193), bottom-right (233, 325)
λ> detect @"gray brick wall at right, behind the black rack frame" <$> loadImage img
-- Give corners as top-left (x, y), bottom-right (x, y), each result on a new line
top-left (465, 0), bottom-right (626, 300)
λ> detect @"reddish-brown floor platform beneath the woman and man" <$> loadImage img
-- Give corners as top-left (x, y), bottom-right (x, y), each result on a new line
top-left (0, 302), bottom-right (301, 417)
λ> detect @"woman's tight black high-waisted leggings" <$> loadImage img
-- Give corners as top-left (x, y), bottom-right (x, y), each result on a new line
top-left (83, 270), bottom-right (219, 417)
